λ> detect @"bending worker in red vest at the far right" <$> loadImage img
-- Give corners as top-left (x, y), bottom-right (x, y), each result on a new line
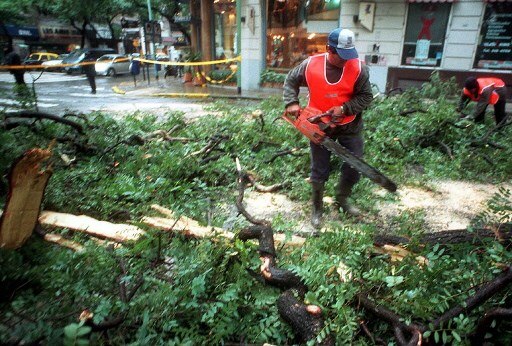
top-left (457, 77), bottom-right (507, 125)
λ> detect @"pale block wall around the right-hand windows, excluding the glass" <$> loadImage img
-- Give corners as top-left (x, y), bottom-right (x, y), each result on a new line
top-left (340, 0), bottom-right (510, 91)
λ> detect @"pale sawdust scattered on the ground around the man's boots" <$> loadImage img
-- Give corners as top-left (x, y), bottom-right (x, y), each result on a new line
top-left (240, 181), bottom-right (512, 233)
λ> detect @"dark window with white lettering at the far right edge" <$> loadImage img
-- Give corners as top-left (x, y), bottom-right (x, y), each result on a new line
top-left (474, 2), bottom-right (512, 69)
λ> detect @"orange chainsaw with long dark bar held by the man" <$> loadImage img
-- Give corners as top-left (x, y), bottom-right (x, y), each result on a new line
top-left (283, 108), bottom-right (397, 192)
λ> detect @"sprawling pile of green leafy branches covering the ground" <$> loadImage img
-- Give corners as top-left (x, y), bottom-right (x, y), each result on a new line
top-left (0, 74), bottom-right (512, 345)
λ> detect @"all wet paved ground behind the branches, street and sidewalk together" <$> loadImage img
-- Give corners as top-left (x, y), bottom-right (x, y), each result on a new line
top-left (0, 72), bottom-right (282, 116)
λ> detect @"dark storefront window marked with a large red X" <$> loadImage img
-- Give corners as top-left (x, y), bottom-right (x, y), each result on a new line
top-left (402, 3), bottom-right (451, 66)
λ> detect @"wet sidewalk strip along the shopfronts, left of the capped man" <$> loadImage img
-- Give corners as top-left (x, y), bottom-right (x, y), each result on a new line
top-left (114, 75), bottom-right (283, 100)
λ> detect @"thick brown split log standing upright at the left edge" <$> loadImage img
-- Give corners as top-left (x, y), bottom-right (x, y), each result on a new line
top-left (0, 149), bottom-right (52, 249)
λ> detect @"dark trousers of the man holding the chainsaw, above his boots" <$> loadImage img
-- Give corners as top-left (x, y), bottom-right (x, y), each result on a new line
top-left (310, 135), bottom-right (364, 187)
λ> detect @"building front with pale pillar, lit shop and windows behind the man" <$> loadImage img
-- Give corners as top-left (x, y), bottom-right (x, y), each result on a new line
top-left (241, 0), bottom-right (512, 92)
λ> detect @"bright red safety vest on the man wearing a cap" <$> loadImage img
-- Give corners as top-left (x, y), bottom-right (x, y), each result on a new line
top-left (306, 53), bottom-right (361, 125)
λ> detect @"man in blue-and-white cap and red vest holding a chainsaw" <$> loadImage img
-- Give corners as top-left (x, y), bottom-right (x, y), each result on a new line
top-left (283, 28), bottom-right (373, 228)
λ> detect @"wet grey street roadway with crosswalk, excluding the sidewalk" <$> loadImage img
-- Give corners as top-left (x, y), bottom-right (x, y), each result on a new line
top-left (0, 72), bottom-right (210, 115)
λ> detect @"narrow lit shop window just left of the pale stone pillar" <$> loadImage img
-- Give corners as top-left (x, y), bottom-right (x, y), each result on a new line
top-left (213, 0), bottom-right (236, 59)
